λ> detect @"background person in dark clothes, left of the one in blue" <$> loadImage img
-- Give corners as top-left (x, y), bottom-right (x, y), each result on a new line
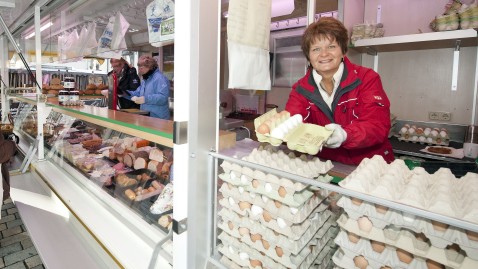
top-left (102, 58), bottom-right (141, 109)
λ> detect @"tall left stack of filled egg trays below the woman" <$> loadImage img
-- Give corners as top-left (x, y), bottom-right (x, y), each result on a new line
top-left (218, 144), bottom-right (338, 269)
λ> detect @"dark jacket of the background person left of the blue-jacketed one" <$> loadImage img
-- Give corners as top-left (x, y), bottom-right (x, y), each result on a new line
top-left (108, 64), bottom-right (141, 109)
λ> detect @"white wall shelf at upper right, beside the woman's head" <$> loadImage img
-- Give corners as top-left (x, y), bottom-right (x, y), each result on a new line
top-left (352, 29), bottom-right (478, 53)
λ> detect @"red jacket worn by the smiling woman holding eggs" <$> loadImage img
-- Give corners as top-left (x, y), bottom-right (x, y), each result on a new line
top-left (285, 57), bottom-right (394, 164)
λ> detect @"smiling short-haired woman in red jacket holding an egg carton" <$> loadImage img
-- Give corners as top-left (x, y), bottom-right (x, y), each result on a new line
top-left (285, 17), bottom-right (394, 165)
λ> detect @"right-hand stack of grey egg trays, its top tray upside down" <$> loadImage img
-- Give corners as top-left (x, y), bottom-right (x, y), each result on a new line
top-left (333, 156), bottom-right (478, 269)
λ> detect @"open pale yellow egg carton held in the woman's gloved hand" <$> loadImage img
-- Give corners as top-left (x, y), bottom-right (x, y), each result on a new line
top-left (254, 109), bottom-right (332, 155)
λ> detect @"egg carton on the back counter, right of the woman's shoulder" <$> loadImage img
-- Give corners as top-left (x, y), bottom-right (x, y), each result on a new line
top-left (398, 124), bottom-right (450, 146)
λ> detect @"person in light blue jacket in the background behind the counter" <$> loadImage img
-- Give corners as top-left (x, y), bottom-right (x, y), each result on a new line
top-left (129, 55), bottom-right (170, 120)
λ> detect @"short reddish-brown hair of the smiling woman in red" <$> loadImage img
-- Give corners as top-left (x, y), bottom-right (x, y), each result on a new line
top-left (302, 17), bottom-right (349, 62)
